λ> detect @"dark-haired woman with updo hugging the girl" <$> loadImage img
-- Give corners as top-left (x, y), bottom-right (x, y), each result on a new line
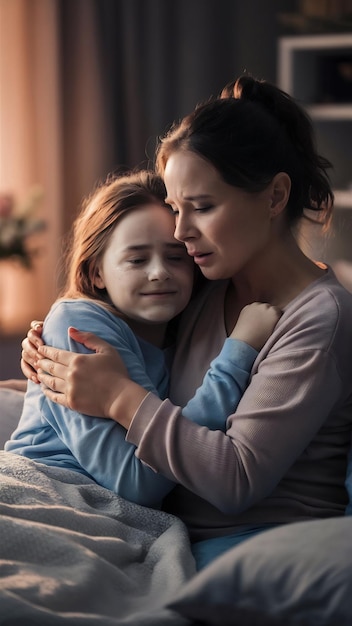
top-left (23, 77), bottom-right (352, 565)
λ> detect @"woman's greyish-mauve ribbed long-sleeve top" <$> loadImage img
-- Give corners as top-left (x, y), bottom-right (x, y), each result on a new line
top-left (127, 269), bottom-right (352, 540)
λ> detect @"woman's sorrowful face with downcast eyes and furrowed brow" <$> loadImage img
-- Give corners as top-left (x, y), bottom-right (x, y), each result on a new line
top-left (164, 151), bottom-right (271, 280)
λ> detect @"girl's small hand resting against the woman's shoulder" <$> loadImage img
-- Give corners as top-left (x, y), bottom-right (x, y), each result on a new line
top-left (230, 302), bottom-right (282, 352)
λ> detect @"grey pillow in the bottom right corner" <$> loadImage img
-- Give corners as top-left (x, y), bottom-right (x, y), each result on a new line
top-left (169, 516), bottom-right (352, 626)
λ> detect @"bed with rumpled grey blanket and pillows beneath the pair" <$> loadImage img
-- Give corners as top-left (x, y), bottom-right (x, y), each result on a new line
top-left (0, 389), bottom-right (352, 626)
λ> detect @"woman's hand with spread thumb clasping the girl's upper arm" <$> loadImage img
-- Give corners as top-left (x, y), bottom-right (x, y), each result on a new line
top-left (37, 327), bottom-right (148, 428)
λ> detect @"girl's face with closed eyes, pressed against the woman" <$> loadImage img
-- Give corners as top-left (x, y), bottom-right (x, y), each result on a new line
top-left (95, 204), bottom-right (194, 327)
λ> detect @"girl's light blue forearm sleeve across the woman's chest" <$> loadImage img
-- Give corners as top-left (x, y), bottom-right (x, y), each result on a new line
top-left (182, 338), bottom-right (258, 432)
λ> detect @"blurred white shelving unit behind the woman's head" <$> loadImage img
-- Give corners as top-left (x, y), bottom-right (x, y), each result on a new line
top-left (277, 33), bottom-right (352, 272)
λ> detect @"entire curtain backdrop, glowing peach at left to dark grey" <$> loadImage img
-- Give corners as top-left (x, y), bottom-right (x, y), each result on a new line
top-left (0, 0), bottom-right (277, 334)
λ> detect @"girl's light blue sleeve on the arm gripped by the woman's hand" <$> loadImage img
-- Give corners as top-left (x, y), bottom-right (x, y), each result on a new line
top-left (43, 301), bottom-right (175, 507)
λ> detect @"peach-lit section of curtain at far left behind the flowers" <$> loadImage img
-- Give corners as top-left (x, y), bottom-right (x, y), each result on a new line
top-left (0, 0), bottom-right (113, 334)
